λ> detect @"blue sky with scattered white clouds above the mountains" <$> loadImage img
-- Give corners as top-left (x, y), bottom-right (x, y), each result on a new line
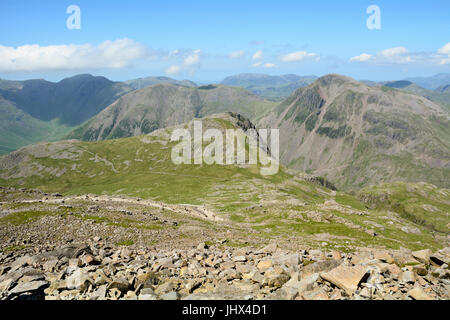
top-left (0, 0), bottom-right (450, 83)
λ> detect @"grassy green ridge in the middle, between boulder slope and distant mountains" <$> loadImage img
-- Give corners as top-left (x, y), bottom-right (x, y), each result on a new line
top-left (0, 114), bottom-right (448, 250)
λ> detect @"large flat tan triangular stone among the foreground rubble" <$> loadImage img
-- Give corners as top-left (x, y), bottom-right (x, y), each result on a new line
top-left (320, 265), bottom-right (367, 296)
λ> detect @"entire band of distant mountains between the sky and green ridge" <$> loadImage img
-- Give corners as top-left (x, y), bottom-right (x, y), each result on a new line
top-left (0, 74), bottom-right (450, 189)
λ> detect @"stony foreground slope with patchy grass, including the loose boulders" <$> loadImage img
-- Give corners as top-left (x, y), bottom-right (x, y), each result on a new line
top-left (0, 188), bottom-right (450, 300)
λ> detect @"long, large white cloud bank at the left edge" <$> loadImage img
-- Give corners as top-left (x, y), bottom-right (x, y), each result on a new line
top-left (0, 39), bottom-right (148, 72)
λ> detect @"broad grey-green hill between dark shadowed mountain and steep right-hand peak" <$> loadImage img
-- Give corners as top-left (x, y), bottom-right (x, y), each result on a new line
top-left (68, 83), bottom-right (277, 141)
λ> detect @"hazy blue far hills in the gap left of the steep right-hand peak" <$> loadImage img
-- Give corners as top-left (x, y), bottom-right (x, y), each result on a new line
top-left (221, 73), bottom-right (317, 99)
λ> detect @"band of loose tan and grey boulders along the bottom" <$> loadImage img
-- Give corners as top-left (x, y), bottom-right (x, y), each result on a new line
top-left (0, 239), bottom-right (450, 300)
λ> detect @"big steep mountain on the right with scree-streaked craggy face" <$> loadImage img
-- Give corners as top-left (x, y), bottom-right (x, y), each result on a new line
top-left (259, 75), bottom-right (450, 189)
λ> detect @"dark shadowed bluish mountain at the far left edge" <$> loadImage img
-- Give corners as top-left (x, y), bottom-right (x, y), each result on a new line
top-left (0, 74), bottom-right (133, 154)
